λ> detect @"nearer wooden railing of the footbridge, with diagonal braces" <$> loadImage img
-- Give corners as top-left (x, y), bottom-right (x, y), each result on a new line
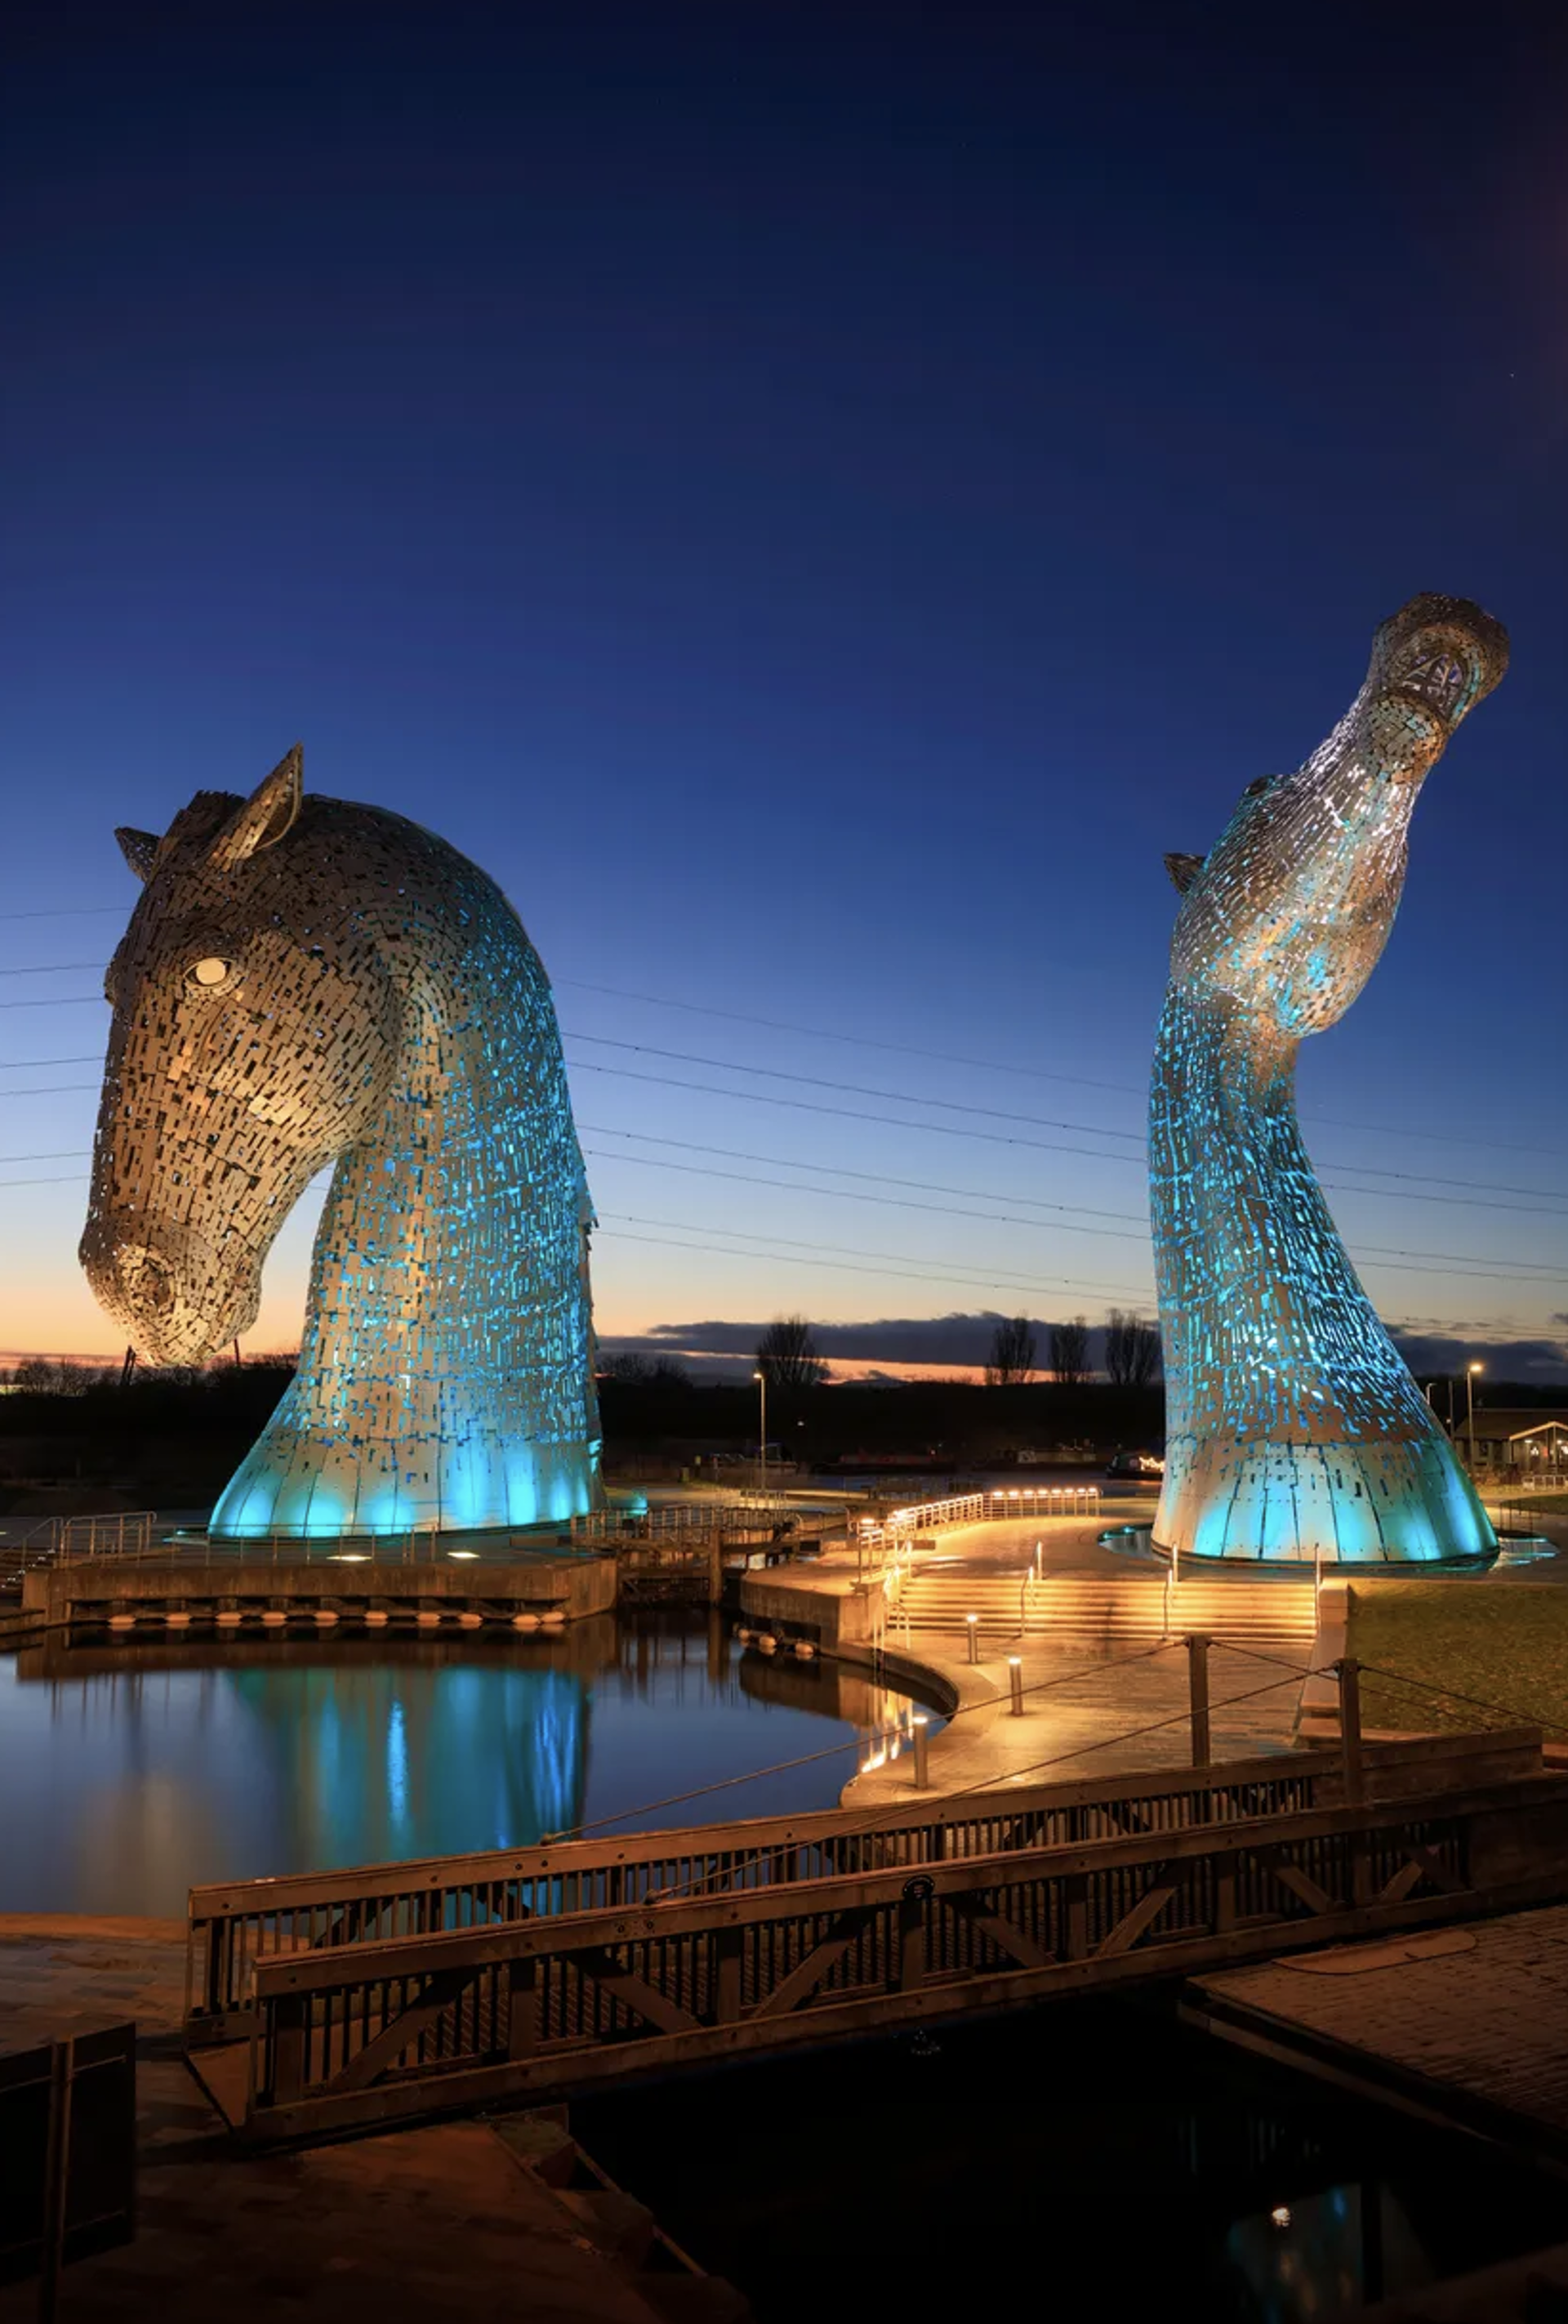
top-left (247, 1747), bottom-right (1568, 2138)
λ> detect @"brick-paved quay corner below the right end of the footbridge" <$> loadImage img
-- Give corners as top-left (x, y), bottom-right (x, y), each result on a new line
top-left (1183, 1903), bottom-right (1568, 2173)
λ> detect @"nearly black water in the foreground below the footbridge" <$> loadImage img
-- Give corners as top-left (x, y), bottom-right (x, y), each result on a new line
top-left (572, 1996), bottom-right (1568, 2324)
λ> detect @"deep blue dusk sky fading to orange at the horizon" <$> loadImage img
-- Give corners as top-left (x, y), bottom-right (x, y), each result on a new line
top-left (0, 0), bottom-right (1568, 1369)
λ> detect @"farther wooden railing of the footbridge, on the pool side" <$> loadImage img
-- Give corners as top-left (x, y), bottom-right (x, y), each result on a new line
top-left (186, 1729), bottom-right (1540, 2036)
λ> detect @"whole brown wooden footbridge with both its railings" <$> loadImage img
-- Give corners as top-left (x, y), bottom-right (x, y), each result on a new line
top-left (188, 1729), bottom-right (1568, 2138)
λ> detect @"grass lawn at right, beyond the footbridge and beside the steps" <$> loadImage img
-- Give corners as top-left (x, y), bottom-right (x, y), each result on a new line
top-left (1345, 1581), bottom-right (1568, 1741)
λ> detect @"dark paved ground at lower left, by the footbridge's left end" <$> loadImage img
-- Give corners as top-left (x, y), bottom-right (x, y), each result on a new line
top-left (0, 1915), bottom-right (748, 2324)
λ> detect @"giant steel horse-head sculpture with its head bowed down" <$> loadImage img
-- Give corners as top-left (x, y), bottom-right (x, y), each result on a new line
top-left (82, 748), bottom-right (602, 1538)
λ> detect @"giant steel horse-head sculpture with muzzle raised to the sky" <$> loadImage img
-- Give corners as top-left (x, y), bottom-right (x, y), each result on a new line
top-left (1150, 597), bottom-right (1508, 1564)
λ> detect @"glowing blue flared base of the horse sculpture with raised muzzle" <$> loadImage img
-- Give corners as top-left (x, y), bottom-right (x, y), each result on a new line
top-left (1152, 1436), bottom-right (1499, 1568)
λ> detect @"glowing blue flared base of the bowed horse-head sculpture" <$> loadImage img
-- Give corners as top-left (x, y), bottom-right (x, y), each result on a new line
top-left (207, 1420), bottom-right (604, 1541)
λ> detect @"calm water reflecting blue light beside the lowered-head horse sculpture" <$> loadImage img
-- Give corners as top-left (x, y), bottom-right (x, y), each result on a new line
top-left (0, 1611), bottom-right (933, 1917)
